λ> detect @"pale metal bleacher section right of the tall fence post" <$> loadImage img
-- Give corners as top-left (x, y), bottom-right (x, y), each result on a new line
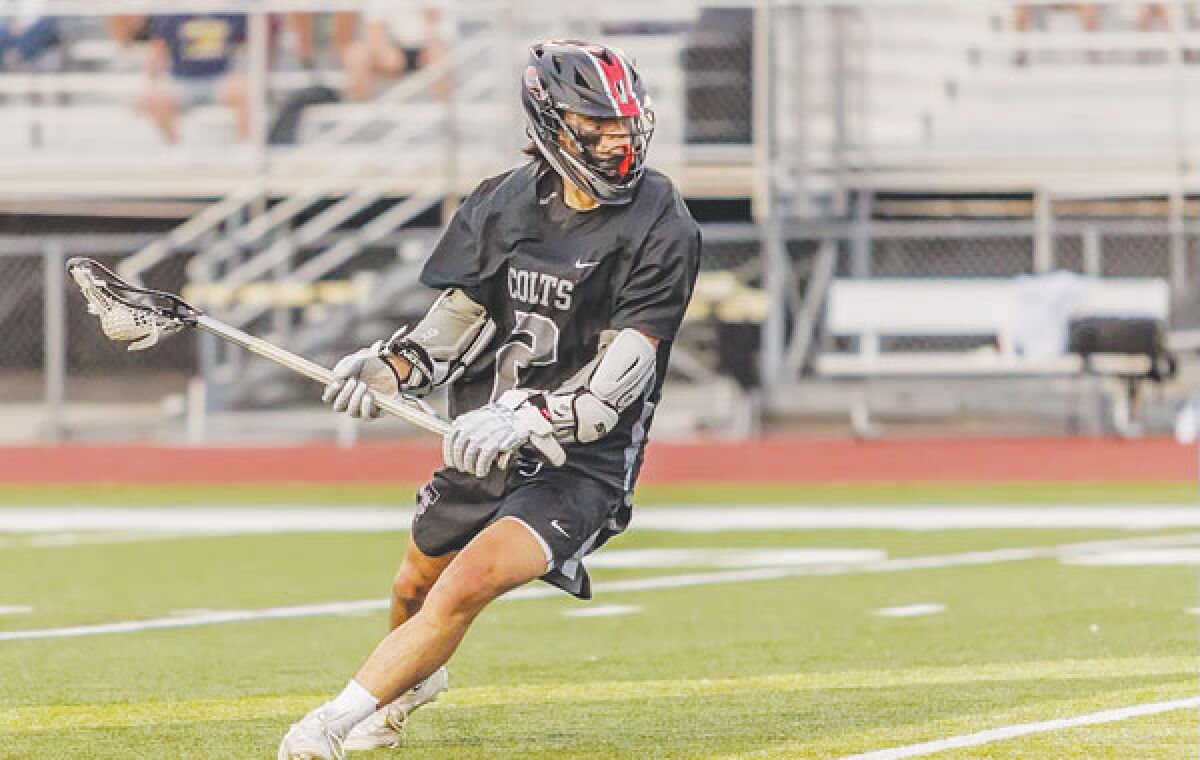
top-left (758, 2), bottom-right (1200, 192)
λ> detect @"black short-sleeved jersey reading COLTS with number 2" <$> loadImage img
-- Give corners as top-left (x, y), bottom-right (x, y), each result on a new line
top-left (421, 162), bottom-right (701, 516)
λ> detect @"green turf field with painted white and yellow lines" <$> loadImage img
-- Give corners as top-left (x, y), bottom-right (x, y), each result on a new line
top-left (0, 485), bottom-right (1200, 760)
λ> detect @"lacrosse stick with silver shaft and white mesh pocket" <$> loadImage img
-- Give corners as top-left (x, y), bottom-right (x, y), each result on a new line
top-left (67, 258), bottom-right (450, 436)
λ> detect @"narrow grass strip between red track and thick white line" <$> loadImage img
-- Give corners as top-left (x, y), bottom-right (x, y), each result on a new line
top-left (0, 481), bottom-right (1198, 507)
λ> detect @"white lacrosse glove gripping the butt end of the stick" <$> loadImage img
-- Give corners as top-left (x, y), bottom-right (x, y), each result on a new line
top-left (442, 390), bottom-right (566, 478)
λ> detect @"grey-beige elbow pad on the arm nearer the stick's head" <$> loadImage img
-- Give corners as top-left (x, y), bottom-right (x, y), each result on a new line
top-left (388, 289), bottom-right (496, 396)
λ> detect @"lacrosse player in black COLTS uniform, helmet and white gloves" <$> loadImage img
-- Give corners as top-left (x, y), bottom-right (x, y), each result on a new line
top-left (278, 41), bottom-right (701, 760)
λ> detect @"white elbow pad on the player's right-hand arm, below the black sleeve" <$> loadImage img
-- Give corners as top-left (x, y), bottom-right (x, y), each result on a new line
top-left (532, 328), bottom-right (658, 443)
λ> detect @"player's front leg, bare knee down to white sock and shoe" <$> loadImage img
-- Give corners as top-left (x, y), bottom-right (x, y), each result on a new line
top-left (278, 519), bottom-right (546, 760)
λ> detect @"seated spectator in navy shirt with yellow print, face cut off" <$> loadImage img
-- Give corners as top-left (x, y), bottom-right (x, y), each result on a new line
top-left (140, 13), bottom-right (250, 143)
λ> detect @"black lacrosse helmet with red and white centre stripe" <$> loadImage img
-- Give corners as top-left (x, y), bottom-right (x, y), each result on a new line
top-left (521, 40), bottom-right (654, 205)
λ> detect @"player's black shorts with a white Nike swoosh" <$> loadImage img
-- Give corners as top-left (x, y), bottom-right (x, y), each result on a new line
top-left (413, 467), bottom-right (623, 599)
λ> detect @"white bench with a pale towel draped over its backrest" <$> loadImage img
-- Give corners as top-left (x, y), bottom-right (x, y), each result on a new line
top-left (816, 279), bottom-right (1170, 377)
